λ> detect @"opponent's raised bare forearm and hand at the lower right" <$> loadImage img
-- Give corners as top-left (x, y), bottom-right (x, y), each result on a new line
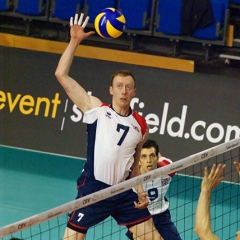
top-left (194, 164), bottom-right (225, 240)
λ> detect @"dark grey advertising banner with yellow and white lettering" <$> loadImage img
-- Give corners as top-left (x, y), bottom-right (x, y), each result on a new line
top-left (0, 47), bottom-right (240, 164)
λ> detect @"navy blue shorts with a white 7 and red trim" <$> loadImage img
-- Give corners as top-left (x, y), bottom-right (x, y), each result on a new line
top-left (67, 175), bottom-right (152, 234)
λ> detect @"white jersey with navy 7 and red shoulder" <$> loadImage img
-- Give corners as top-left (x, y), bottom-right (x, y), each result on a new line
top-left (83, 104), bottom-right (147, 185)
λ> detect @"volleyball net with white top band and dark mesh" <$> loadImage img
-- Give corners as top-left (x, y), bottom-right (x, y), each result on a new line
top-left (0, 138), bottom-right (240, 240)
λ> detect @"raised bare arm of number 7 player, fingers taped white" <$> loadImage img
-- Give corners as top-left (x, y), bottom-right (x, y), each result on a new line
top-left (55, 14), bottom-right (101, 113)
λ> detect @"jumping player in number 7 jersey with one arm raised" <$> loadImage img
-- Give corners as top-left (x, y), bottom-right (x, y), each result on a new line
top-left (55, 14), bottom-right (162, 240)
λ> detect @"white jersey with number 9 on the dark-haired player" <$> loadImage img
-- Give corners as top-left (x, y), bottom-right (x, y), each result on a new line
top-left (143, 157), bottom-right (172, 215)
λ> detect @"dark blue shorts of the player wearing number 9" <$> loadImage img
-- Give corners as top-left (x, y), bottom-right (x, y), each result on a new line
top-left (126, 209), bottom-right (181, 240)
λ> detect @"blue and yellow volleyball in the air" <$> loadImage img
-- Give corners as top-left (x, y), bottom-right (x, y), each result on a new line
top-left (94, 8), bottom-right (126, 38)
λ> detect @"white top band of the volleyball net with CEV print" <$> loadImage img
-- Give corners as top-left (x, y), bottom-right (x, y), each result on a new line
top-left (0, 138), bottom-right (240, 238)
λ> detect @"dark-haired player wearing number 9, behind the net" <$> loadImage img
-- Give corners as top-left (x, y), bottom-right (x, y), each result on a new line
top-left (127, 139), bottom-right (181, 240)
